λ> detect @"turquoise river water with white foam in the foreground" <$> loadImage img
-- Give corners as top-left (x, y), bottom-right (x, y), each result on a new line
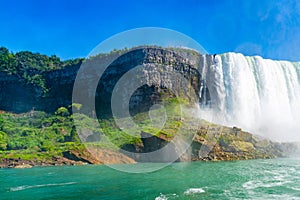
top-left (0, 159), bottom-right (300, 200)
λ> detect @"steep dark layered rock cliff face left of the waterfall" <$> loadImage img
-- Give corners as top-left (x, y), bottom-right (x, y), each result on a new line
top-left (0, 47), bottom-right (212, 113)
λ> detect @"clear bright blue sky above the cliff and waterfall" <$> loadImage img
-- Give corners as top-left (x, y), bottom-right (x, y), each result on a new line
top-left (0, 0), bottom-right (300, 61)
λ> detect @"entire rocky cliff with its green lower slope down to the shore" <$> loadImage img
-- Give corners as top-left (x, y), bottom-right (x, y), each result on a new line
top-left (0, 47), bottom-right (294, 167)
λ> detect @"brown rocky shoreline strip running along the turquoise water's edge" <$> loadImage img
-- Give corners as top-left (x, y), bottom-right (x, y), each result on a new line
top-left (0, 124), bottom-right (298, 168)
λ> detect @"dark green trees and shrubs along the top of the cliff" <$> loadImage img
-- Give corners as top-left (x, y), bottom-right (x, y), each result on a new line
top-left (0, 46), bottom-right (202, 94)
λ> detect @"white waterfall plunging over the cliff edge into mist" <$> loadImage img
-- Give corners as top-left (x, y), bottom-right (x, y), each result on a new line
top-left (204, 53), bottom-right (300, 141)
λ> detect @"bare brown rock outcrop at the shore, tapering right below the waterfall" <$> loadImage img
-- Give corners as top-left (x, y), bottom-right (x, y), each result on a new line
top-left (121, 122), bottom-right (295, 162)
